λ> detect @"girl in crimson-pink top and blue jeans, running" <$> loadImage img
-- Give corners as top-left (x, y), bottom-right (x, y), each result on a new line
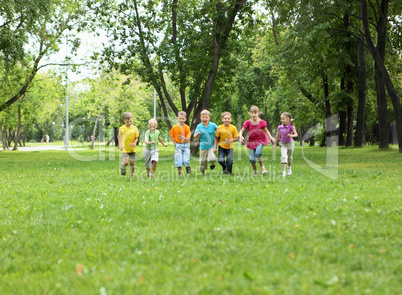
top-left (239, 105), bottom-right (275, 175)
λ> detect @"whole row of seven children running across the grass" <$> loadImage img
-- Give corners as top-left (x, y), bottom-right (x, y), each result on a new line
top-left (118, 105), bottom-right (298, 179)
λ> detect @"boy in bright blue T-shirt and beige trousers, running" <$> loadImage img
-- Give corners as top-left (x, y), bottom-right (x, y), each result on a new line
top-left (194, 110), bottom-right (218, 175)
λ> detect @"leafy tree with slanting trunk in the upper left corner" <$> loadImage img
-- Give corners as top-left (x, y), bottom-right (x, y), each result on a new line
top-left (0, 0), bottom-right (85, 112)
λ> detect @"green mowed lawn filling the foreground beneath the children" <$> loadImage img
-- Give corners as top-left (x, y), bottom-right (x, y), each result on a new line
top-left (0, 145), bottom-right (402, 295)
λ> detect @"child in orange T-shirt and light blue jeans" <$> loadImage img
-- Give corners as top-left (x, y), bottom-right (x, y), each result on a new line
top-left (169, 111), bottom-right (191, 177)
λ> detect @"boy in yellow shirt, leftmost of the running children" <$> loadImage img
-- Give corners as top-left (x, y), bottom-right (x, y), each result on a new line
top-left (117, 112), bottom-right (139, 180)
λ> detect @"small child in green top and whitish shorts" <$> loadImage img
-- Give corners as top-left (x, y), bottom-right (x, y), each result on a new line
top-left (144, 119), bottom-right (167, 178)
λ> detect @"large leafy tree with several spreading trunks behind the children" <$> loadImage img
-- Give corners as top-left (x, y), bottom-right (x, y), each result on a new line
top-left (94, 0), bottom-right (250, 135)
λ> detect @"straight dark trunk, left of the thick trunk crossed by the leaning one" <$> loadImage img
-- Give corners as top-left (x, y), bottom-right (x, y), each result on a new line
top-left (355, 10), bottom-right (366, 147)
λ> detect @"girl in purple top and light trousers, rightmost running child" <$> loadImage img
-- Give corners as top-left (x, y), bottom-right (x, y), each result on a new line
top-left (273, 113), bottom-right (298, 177)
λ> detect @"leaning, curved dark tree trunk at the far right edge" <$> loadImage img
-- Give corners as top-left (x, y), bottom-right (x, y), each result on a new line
top-left (361, 0), bottom-right (402, 153)
